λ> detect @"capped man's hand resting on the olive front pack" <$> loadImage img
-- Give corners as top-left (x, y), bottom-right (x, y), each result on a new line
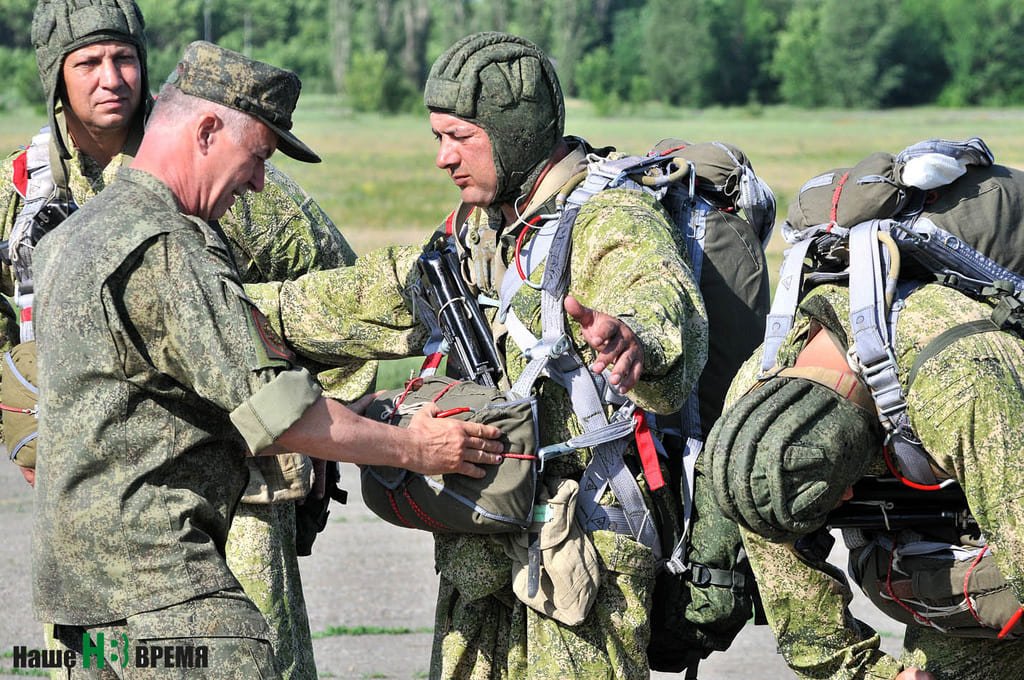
top-left (403, 402), bottom-right (504, 479)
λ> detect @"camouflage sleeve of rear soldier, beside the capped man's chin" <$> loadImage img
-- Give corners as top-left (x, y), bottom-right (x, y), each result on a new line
top-left (220, 163), bottom-right (355, 283)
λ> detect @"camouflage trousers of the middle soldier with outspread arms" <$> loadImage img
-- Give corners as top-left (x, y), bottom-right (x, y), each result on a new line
top-left (430, 532), bottom-right (654, 680)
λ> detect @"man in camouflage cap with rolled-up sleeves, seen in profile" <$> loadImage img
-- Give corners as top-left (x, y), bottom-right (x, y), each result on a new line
top-left (33, 42), bottom-right (501, 678)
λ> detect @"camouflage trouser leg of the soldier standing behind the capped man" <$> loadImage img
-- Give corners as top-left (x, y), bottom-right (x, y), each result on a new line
top-left (225, 502), bottom-right (316, 680)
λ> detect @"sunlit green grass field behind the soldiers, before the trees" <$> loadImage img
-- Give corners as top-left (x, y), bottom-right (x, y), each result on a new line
top-left (0, 101), bottom-right (1024, 386)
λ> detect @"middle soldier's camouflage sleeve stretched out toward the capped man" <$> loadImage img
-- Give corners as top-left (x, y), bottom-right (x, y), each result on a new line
top-left (246, 240), bottom-right (427, 366)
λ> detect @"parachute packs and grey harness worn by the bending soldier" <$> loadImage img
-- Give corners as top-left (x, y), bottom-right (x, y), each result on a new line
top-left (761, 137), bottom-right (1024, 638)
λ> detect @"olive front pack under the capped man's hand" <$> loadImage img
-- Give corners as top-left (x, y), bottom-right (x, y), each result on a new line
top-left (360, 376), bottom-right (538, 534)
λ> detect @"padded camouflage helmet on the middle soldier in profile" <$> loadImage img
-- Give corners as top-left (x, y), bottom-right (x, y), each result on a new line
top-left (423, 32), bottom-right (565, 205)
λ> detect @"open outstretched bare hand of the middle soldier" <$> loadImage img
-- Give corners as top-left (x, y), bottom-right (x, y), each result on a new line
top-left (564, 295), bottom-right (643, 394)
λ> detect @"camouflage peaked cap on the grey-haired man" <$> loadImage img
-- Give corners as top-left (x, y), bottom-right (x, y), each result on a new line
top-left (167, 40), bottom-right (321, 163)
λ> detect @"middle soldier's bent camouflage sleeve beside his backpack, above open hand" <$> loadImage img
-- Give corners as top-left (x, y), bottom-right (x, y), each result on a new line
top-left (568, 189), bottom-right (708, 413)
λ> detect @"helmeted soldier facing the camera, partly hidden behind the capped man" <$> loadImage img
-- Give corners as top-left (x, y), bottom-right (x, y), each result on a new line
top-left (0, 0), bottom-right (366, 678)
